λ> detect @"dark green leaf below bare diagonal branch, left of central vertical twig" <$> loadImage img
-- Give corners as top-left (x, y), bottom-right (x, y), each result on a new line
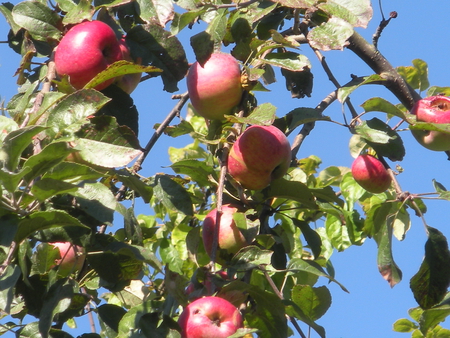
top-left (153, 175), bottom-right (194, 216)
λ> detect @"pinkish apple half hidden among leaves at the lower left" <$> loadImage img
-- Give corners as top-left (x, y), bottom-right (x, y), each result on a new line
top-left (49, 242), bottom-right (86, 276)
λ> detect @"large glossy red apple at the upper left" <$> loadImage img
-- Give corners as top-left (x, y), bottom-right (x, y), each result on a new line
top-left (55, 21), bottom-right (123, 90)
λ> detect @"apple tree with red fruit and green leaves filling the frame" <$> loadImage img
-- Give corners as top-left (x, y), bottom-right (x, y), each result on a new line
top-left (0, 0), bottom-right (450, 338)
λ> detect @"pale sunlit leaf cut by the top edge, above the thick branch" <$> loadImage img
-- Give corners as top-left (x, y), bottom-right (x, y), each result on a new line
top-left (318, 0), bottom-right (373, 28)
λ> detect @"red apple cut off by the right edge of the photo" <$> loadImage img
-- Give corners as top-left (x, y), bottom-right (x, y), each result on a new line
top-left (411, 95), bottom-right (450, 151)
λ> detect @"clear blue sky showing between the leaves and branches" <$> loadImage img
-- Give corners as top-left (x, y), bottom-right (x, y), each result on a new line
top-left (0, 0), bottom-right (450, 338)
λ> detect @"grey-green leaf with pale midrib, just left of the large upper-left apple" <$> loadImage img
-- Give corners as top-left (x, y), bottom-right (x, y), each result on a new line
top-left (12, 1), bottom-right (61, 41)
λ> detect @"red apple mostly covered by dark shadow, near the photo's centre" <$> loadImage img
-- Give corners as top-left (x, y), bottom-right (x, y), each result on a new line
top-left (227, 126), bottom-right (292, 190)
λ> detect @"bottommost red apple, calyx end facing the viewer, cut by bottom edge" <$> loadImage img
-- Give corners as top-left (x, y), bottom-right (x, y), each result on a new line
top-left (178, 297), bottom-right (242, 338)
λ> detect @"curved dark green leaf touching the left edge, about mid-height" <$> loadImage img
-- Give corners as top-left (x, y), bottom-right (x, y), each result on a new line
top-left (0, 126), bottom-right (45, 171)
